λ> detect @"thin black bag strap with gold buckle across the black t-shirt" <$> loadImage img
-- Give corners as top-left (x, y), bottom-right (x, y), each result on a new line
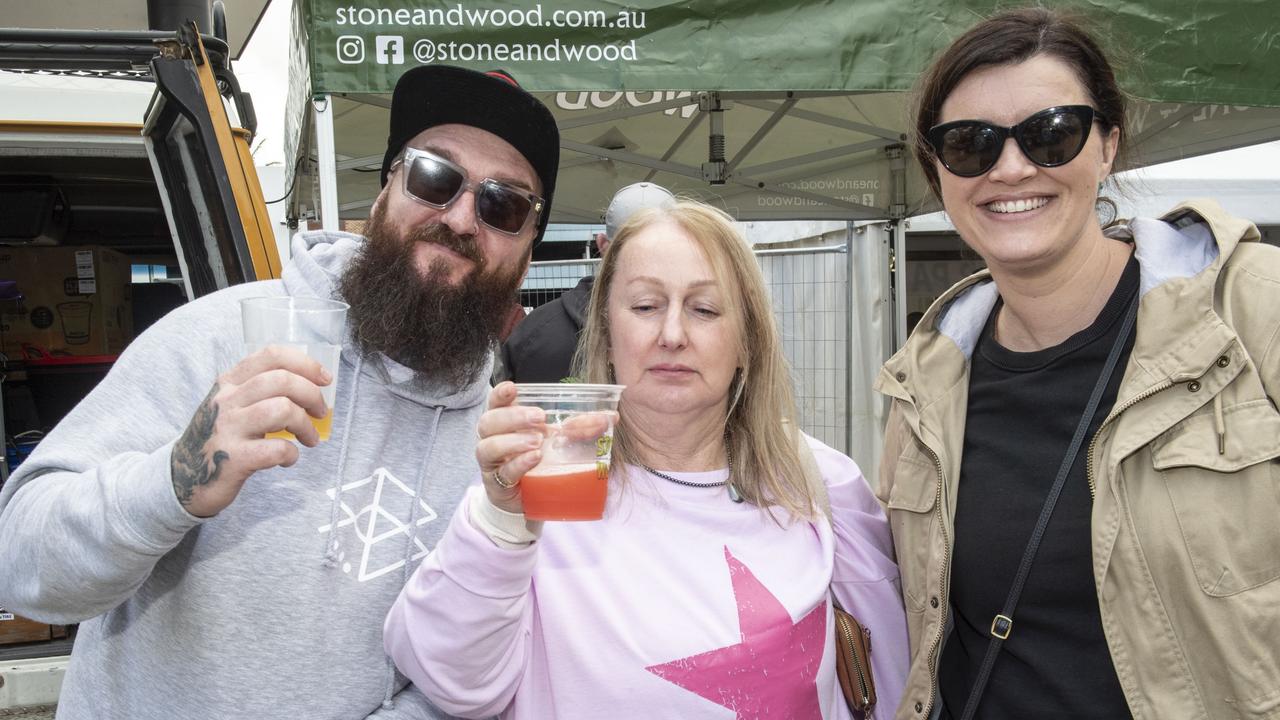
top-left (961, 292), bottom-right (1138, 720)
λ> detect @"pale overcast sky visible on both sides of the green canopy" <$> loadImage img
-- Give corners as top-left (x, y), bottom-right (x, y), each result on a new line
top-left (234, 0), bottom-right (1280, 179)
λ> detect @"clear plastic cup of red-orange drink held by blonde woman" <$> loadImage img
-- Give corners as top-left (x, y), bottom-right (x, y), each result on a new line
top-left (516, 383), bottom-right (623, 520)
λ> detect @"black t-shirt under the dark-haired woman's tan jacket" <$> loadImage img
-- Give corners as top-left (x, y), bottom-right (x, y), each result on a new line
top-left (938, 258), bottom-right (1138, 720)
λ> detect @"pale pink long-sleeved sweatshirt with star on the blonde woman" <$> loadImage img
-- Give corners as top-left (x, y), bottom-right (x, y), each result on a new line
top-left (384, 438), bottom-right (908, 720)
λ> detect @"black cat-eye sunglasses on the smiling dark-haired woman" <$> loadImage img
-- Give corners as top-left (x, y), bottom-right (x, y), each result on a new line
top-left (924, 105), bottom-right (1106, 178)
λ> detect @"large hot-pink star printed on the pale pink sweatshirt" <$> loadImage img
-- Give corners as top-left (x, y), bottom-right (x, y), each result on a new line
top-left (646, 547), bottom-right (827, 720)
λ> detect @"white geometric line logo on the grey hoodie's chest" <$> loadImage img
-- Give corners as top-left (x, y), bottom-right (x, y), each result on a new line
top-left (319, 468), bottom-right (438, 583)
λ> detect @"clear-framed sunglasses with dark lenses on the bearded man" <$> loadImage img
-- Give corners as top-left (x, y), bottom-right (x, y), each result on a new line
top-left (390, 147), bottom-right (543, 234)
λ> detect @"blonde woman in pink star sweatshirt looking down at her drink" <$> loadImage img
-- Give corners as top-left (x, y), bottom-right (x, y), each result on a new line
top-left (384, 201), bottom-right (906, 720)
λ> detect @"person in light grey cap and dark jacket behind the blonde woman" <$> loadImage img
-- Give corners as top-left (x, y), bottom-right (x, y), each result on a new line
top-left (494, 182), bottom-right (675, 383)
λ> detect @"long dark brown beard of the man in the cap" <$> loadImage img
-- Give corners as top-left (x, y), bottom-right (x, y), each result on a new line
top-left (340, 204), bottom-right (524, 389)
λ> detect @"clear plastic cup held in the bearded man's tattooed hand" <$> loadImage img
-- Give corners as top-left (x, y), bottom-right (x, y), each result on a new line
top-left (241, 296), bottom-right (347, 442)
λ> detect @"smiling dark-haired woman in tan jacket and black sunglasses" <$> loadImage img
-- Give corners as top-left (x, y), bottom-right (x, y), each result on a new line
top-left (877, 8), bottom-right (1280, 720)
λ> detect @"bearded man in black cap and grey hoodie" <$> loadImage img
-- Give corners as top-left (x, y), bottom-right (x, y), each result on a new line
top-left (0, 67), bottom-right (559, 720)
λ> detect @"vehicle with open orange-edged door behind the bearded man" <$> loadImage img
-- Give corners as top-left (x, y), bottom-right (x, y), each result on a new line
top-left (0, 0), bottom-right (280, 716)
